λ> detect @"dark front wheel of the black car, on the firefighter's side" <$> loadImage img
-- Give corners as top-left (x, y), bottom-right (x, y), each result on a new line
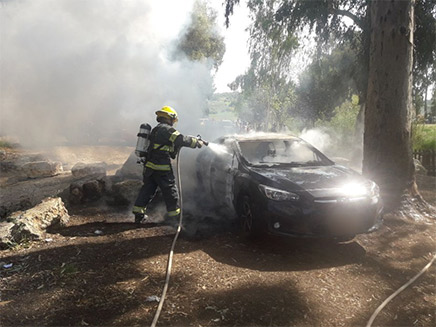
top-left (239, 196), bottom-right (265, 239)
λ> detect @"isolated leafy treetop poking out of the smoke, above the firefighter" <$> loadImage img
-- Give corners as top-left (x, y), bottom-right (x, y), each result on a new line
top-left (177, 0), bottom-right (225, 70)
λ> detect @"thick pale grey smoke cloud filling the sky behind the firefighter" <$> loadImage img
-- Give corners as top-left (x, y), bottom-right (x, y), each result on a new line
top-left (0, 0), bottom-right (212, 145)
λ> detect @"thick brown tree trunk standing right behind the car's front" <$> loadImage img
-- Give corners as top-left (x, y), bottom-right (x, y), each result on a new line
top-left (363, 0), bottom-right (417, 210)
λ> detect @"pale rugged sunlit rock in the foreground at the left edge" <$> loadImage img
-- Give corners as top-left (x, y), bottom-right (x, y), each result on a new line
top-left (0, 198), bottom-right (69, 248)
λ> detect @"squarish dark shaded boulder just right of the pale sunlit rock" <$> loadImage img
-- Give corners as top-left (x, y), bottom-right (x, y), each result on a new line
top-left (69, 179), bottom-right (106, 204)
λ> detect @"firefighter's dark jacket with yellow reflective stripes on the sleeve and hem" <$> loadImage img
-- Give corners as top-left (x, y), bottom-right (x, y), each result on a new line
top-left (145, 123), bottom-right (198, 171)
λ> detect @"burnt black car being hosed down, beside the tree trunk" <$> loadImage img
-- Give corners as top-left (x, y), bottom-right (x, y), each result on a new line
top-left (197, 134), bottom-right (383, 240)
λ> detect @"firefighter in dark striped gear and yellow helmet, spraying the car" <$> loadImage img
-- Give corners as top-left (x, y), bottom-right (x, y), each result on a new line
top-left (132, 106), bottom-right (203, 224)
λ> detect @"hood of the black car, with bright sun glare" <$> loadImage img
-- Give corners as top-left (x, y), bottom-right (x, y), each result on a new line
top-left (251, 165), bottom-right (367, 198)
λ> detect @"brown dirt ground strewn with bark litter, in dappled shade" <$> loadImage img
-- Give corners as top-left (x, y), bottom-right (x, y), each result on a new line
top-left (0, 147), bottom-right (436, 326)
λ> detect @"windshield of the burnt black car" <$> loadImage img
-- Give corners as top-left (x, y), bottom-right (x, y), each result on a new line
top-left (238, 139), bottom-right (333, 167)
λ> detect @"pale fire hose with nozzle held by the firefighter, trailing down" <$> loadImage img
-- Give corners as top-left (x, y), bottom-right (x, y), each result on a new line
top-left (151, 135), bottom-right (209, 327)
